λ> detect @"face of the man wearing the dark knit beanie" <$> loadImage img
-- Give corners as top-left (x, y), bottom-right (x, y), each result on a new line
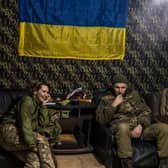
top-left (113, 83), bottom-right (128, 96)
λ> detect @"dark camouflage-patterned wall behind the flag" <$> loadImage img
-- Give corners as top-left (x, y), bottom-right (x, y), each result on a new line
top-left (0, 0), bottom-right (168, 94)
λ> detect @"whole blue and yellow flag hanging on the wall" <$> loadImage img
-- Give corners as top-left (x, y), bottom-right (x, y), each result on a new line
top-left (19, 0), bottom-right (128, 60)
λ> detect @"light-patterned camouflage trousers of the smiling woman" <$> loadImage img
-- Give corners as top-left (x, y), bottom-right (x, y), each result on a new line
top-left (0, 124), bottom-right (57, 168)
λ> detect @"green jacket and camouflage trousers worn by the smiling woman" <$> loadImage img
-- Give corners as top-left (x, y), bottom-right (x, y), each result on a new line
top-left (0, 96), bottom-right (61, 168)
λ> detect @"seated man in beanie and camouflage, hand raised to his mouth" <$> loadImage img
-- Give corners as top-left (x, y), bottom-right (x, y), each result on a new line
top-left (96, 75), bottom-right (168, 168)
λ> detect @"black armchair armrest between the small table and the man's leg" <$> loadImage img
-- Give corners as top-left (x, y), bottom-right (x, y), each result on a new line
top-left (91, 121), bottom-right (121, 168)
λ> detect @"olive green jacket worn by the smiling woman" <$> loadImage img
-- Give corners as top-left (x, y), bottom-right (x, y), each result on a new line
top-left (2, 96), bottom-right (49, 146)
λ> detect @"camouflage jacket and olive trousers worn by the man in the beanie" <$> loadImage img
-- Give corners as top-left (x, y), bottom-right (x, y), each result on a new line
top-left (96, 91), bottom-right (168, 158)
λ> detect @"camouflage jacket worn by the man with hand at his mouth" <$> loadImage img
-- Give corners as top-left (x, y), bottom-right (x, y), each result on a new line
top-left (96, 91), bottom-right (151, 128)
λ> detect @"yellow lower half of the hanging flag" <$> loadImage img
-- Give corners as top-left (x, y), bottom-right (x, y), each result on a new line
top-left (19, 22), bottom-right (126, 60)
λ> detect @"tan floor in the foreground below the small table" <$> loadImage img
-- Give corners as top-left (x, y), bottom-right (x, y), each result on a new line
top-left (56, 153), bottom-right (105, 168)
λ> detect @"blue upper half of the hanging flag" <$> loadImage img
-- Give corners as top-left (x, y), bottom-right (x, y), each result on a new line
top-left (19, 0), bottom-right (128, 27)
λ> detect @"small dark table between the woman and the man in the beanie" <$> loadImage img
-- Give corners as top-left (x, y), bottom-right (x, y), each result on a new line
top-left (47, 102), bottom-right (96, 153)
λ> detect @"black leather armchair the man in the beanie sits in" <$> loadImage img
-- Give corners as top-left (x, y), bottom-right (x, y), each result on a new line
top-left (91, 90), bottom-right (160, 168)
